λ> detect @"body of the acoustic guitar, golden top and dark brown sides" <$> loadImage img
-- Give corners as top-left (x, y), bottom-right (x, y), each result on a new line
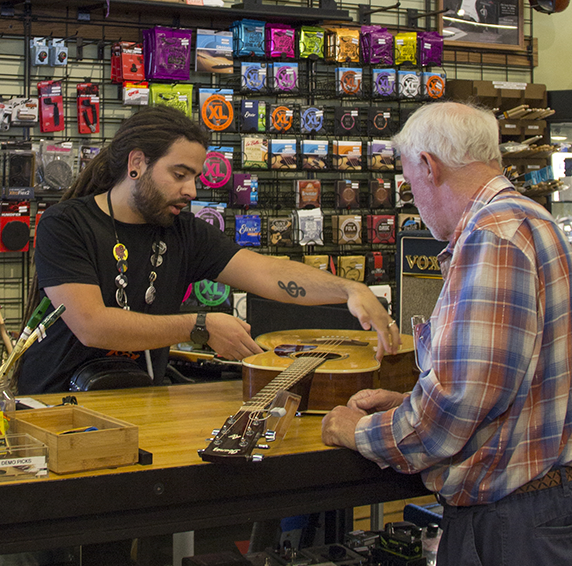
top-left (242, 330), bottom-right (380, 411)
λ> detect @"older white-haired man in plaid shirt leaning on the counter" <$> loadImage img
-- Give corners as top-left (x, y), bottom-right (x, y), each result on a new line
top-left (323, 102), bottom-right (572, 566)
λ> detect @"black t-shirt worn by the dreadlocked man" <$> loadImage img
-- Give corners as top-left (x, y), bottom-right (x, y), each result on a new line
top-left (19, 196), bottom-right (240, 394)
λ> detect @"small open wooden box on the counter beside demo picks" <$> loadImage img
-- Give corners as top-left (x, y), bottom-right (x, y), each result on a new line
top-left (10, 405), bottom-right (139, 474)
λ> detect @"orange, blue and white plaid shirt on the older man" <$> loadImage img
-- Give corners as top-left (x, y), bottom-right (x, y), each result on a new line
top-left (355, 176), bottom-right (572, 505)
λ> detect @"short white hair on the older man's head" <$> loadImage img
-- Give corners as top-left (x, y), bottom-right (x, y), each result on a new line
top-left (393, 102), bottom-right (502, 169)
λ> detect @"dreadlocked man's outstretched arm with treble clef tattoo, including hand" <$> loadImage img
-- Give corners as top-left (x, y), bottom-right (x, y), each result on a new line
top-left (217, 250), bottom-right (399, 359)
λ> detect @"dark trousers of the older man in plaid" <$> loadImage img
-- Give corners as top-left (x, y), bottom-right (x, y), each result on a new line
top-left (437, 474), bottom-right (572, 566)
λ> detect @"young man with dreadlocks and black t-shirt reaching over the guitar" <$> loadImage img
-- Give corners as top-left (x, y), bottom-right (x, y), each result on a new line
top-left (19, 106), bottom-right (399, 394)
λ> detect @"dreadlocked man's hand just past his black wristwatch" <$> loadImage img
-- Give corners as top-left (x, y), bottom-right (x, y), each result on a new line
top-left (206, 312), bottom-right (263, 360)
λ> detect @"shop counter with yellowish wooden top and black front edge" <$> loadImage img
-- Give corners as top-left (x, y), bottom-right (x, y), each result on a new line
top-left (0, 381), bottom-right (427, 553)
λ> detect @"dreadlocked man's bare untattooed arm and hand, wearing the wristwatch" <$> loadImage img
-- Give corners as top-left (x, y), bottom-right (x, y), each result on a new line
top-left (45, 283), bottom-right (262, 359)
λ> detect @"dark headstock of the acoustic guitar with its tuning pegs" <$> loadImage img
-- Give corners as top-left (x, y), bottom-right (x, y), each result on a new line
top-left (199, 411), bottom-right (272, 462)
